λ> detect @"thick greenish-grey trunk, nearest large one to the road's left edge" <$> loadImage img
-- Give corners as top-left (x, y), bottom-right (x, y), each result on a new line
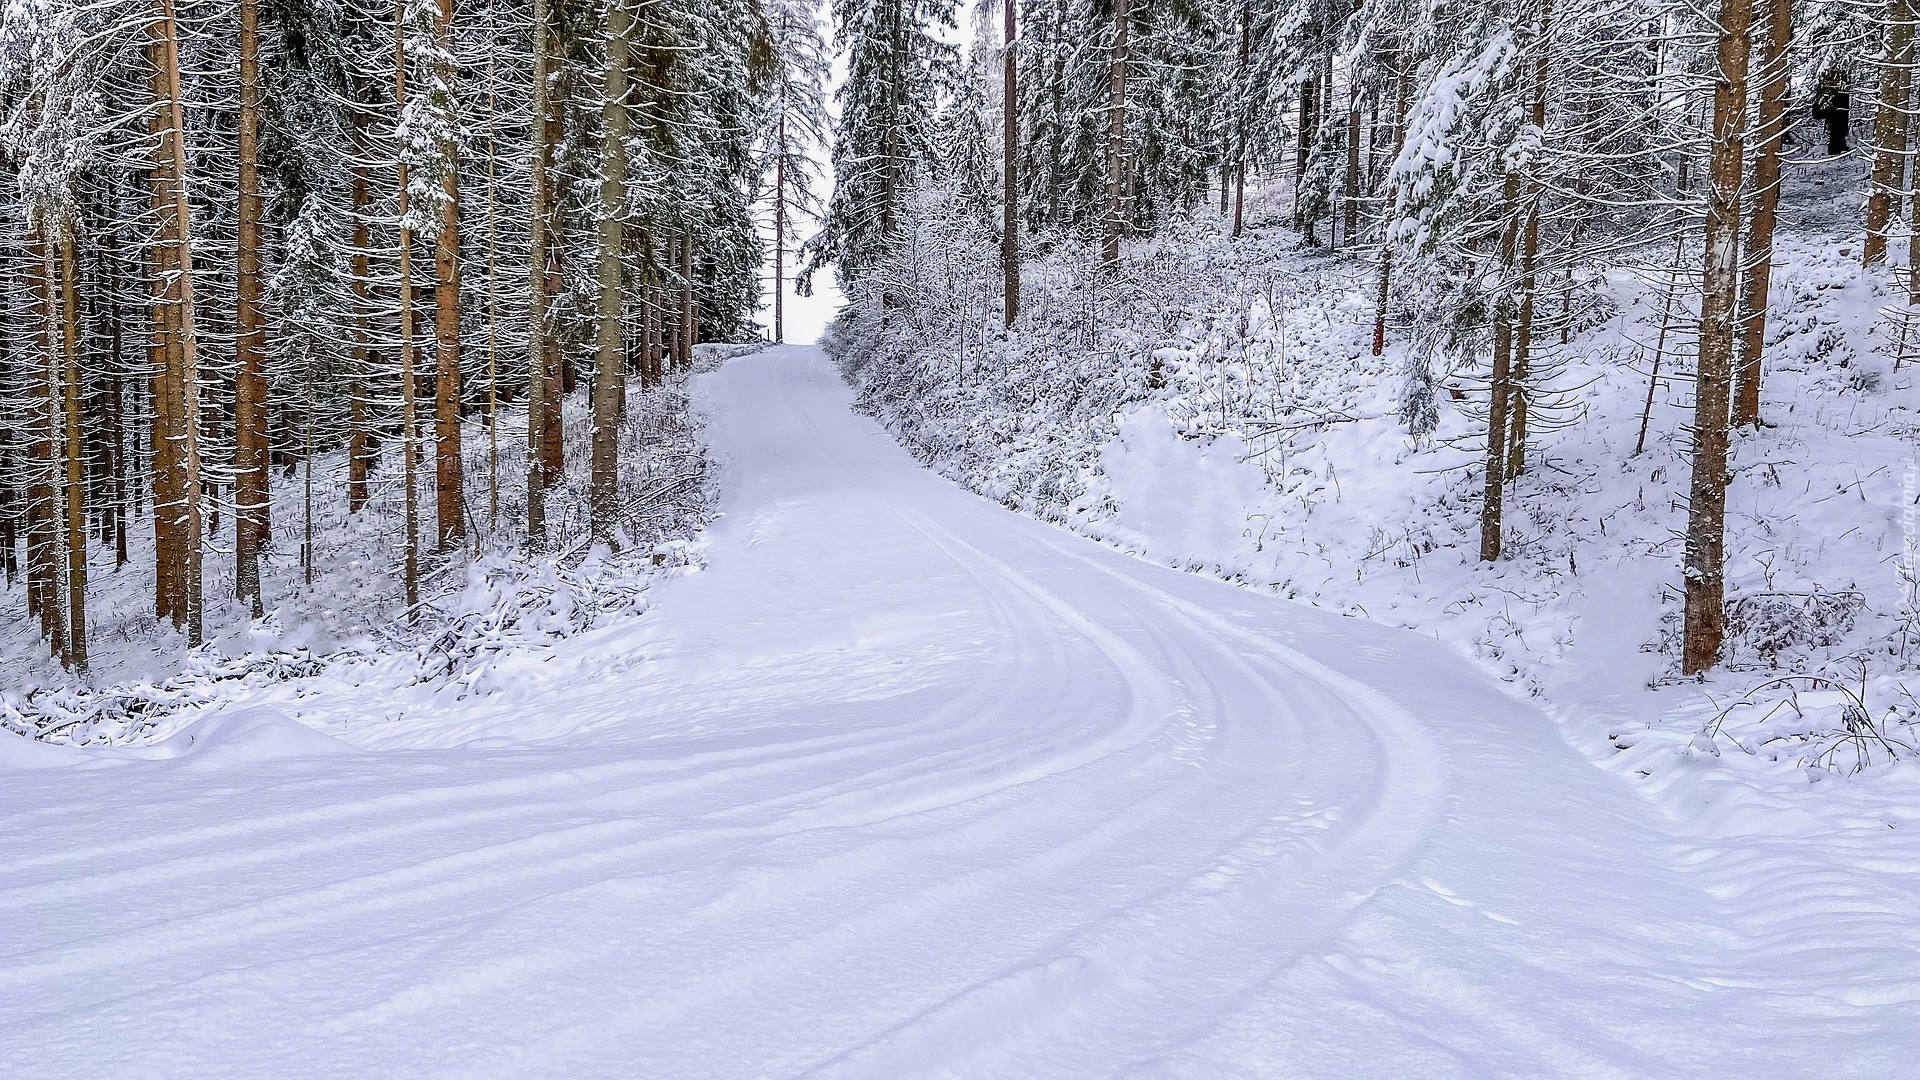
top-left (589, 0), bottom-right (632, 542)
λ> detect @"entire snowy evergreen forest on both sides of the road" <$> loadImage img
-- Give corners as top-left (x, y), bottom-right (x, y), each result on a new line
top-left (0, 0), bottom-right (1920, 673)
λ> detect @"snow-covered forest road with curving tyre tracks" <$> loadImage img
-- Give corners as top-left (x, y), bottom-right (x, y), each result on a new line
top-left (0, 348), bottom-right (1920, 1080)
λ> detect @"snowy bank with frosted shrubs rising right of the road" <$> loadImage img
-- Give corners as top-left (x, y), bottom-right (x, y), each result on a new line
top-left (829, 163), bottom-right (1920, 805)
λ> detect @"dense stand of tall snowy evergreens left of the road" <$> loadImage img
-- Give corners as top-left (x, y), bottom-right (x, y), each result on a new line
top-left (0, 0), bottom-right (824, 669)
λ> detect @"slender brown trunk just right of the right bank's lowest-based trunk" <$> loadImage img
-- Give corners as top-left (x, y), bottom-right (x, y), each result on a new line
top-left (1734, 0), bottom-right (1789, 427)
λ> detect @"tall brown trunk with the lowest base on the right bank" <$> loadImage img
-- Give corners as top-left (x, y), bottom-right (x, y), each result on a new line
top-left (1680, 0), bottom-right (1753, 675)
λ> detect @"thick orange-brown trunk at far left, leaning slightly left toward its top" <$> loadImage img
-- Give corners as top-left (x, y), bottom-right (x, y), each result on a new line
top-left (148, 0), bottom-right (202, 648)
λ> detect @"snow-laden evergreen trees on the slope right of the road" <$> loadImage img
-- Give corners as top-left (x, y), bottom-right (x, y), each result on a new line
top-left (814, 0), bottom-right (1889, 675)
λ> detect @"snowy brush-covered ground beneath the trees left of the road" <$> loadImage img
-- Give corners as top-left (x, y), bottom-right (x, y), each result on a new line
top-left (0, 346), bottom-right (751, 746)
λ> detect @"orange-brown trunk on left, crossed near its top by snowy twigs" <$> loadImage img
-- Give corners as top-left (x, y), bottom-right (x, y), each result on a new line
top-left (434, 0), bottom-right (467, 550)
